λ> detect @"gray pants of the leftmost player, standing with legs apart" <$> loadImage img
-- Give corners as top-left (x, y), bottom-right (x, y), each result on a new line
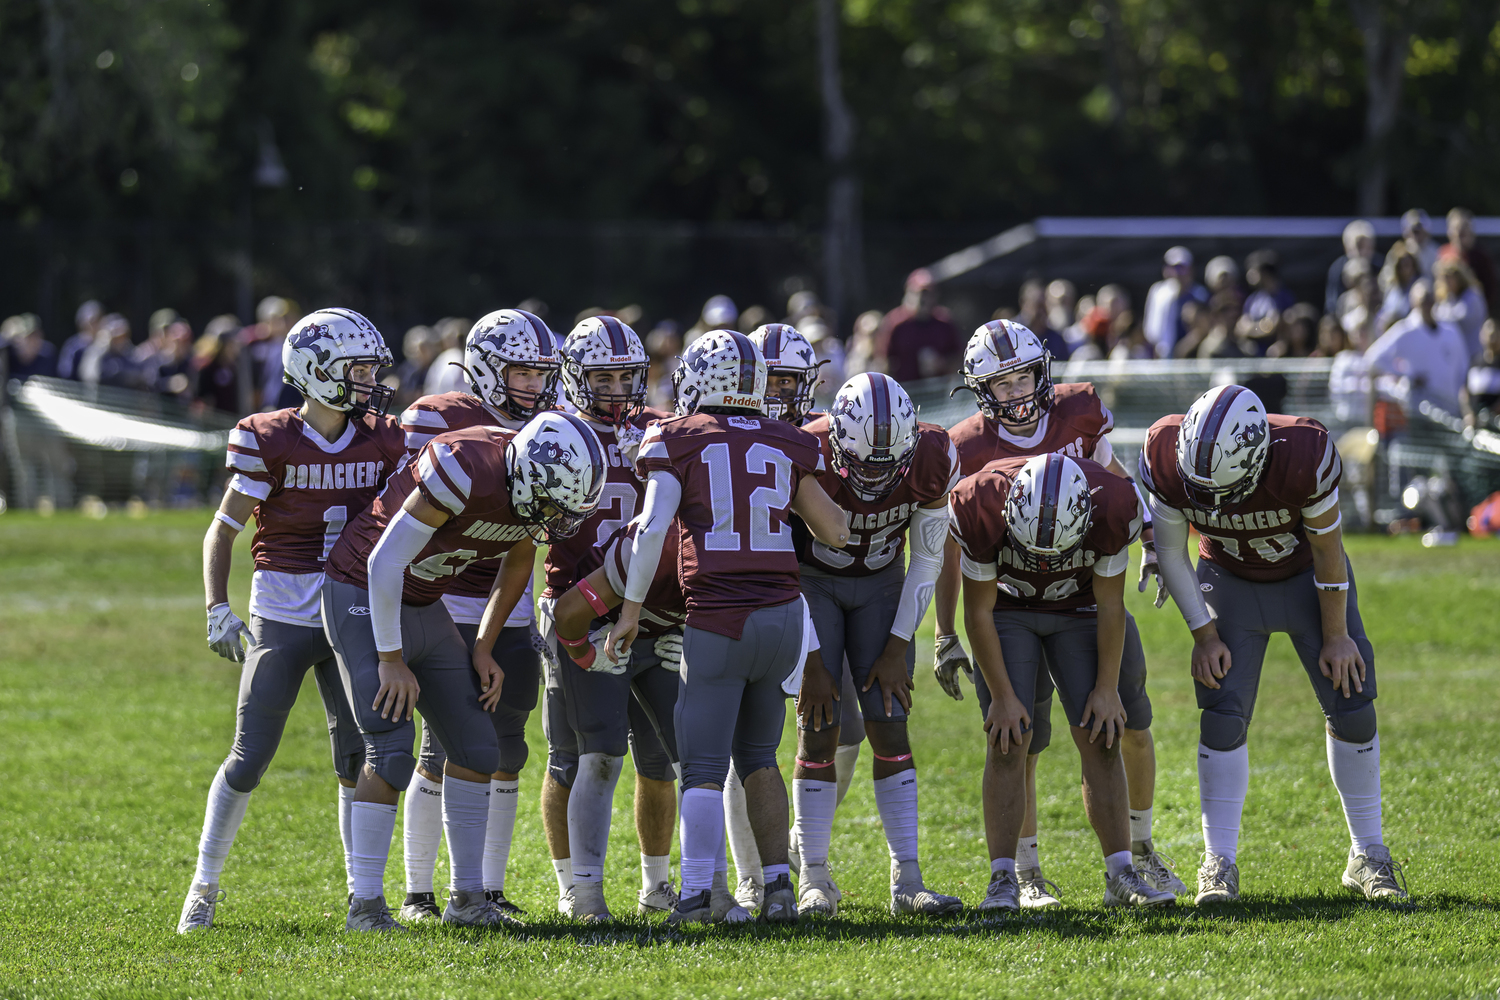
top-left (224, 615), bottom-right (365, 792)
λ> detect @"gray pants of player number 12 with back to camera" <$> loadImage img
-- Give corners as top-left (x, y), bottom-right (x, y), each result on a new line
top-left (677, 601), bottom-right (803, 790)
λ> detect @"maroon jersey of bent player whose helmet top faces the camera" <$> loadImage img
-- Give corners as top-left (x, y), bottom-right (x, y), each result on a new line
top-left (948, 457), bottom-right (1142, 615)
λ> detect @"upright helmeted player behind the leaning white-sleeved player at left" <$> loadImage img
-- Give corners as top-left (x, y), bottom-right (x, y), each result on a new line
top-left (398, 309), bottom-right (563, 921)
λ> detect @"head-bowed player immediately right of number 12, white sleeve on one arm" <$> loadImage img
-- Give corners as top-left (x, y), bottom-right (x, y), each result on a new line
top-left (792, 373), bottom-right (963, 916)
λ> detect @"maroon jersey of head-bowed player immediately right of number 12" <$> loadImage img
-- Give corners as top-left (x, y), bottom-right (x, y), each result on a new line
top-left (803, 417), bottom-right (959, 576)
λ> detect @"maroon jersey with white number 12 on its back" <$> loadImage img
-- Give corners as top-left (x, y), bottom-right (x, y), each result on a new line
top-left (636, 414), bottom-right (824, 639)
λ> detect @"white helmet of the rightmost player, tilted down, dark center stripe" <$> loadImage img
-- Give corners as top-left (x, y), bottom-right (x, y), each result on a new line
top-left (1178, 385), bottom-right (1271, 511)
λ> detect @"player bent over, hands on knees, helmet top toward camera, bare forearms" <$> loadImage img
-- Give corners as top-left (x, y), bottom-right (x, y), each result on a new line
top-left (951, 453), bottom-right (1176, 910)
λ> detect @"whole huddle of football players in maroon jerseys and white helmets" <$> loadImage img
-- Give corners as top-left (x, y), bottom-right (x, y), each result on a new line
top-left (177, 309), bottom-right (1406, 933)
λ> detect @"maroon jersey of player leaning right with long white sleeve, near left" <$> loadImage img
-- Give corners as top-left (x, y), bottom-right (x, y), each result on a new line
top-left (327, 427), bottom-right (527, 606)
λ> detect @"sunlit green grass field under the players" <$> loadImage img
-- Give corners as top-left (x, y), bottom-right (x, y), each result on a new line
top-left (0, 513), bottom-right (1500, 999)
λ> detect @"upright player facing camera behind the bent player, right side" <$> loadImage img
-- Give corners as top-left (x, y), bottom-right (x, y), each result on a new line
top-left (935, 319), bottom-right (1188, 909)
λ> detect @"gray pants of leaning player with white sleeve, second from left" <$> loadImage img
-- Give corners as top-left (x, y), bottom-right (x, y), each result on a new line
top-left (323, 579), bottom-right (500, 790)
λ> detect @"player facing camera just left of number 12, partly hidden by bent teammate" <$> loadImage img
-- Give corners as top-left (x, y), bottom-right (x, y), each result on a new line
top-left (542, 316), bottom-right (677, 922)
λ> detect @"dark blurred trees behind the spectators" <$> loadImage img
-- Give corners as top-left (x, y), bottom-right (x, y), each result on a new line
top-left (0, 0), bottom-right (1500, 337)
